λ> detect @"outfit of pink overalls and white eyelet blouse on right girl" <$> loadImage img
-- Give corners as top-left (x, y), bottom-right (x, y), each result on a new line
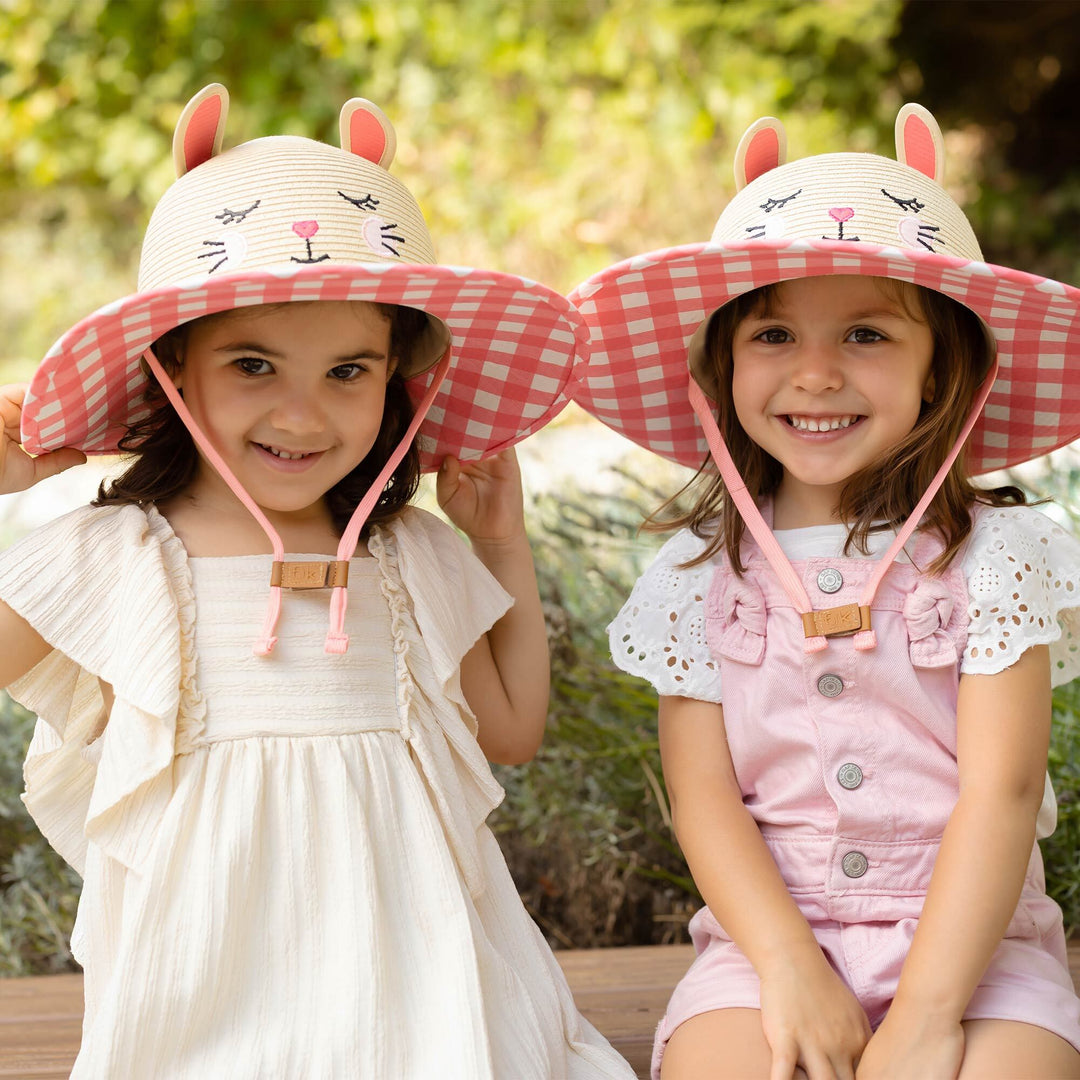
top-left (611, 508), bottom-right (1080, 1077)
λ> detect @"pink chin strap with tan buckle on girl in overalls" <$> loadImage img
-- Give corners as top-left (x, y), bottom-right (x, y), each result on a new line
top-left (689, 359), bottom-right (998, 652)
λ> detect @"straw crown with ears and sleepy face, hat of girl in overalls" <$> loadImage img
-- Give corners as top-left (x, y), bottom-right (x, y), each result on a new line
top-left (712, 105), bottom-right (982, 260)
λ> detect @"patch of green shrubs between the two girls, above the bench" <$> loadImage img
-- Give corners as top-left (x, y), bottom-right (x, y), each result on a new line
top-left (491, 481), bottom-right (700, 947)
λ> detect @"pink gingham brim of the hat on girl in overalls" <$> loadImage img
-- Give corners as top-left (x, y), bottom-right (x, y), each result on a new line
top-left (570, 240), bottom-right (1080, 475)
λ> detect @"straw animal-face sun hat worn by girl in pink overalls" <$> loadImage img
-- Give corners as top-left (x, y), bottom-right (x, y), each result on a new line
top-left (570, 105), bottom-right (1080, 474)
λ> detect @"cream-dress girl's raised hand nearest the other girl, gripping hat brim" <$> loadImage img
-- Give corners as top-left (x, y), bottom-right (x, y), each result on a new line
top-left (435, 449), bottom-right (525, 544)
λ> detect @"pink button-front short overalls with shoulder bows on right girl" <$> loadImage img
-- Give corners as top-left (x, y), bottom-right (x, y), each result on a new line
top-left (653, 518), bottom-right (1080, 1078)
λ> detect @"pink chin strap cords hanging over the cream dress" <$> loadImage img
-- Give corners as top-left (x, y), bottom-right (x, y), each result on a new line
top-left (143, 347), bottom-right (450, 657)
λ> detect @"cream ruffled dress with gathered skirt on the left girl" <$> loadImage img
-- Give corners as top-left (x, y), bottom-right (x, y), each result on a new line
top-left (0, 507), bottom-right (633, 1080)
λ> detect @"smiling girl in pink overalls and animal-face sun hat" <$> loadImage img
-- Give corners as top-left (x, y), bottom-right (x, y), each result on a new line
top-left (572, 106), bottom-right (1080, 1080)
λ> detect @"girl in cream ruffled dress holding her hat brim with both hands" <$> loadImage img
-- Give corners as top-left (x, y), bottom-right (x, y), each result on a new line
top-left (0, 86), bottom-right (633, 1080)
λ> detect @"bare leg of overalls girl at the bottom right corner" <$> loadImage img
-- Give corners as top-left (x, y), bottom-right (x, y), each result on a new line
top-left (958, 1020), bottom-right (1080, 1080)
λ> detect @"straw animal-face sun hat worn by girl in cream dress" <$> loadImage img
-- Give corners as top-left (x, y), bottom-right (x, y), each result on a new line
top-left (22, 84), bottom-right (588, 469)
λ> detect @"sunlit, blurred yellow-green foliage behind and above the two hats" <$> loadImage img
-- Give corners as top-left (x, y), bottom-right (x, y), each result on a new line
top-left (0, 0), bottom-right (901, 378)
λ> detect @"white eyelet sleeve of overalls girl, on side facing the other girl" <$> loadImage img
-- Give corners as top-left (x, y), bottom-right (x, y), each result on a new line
top-left (608, 529), bottom-right (721, 702)
